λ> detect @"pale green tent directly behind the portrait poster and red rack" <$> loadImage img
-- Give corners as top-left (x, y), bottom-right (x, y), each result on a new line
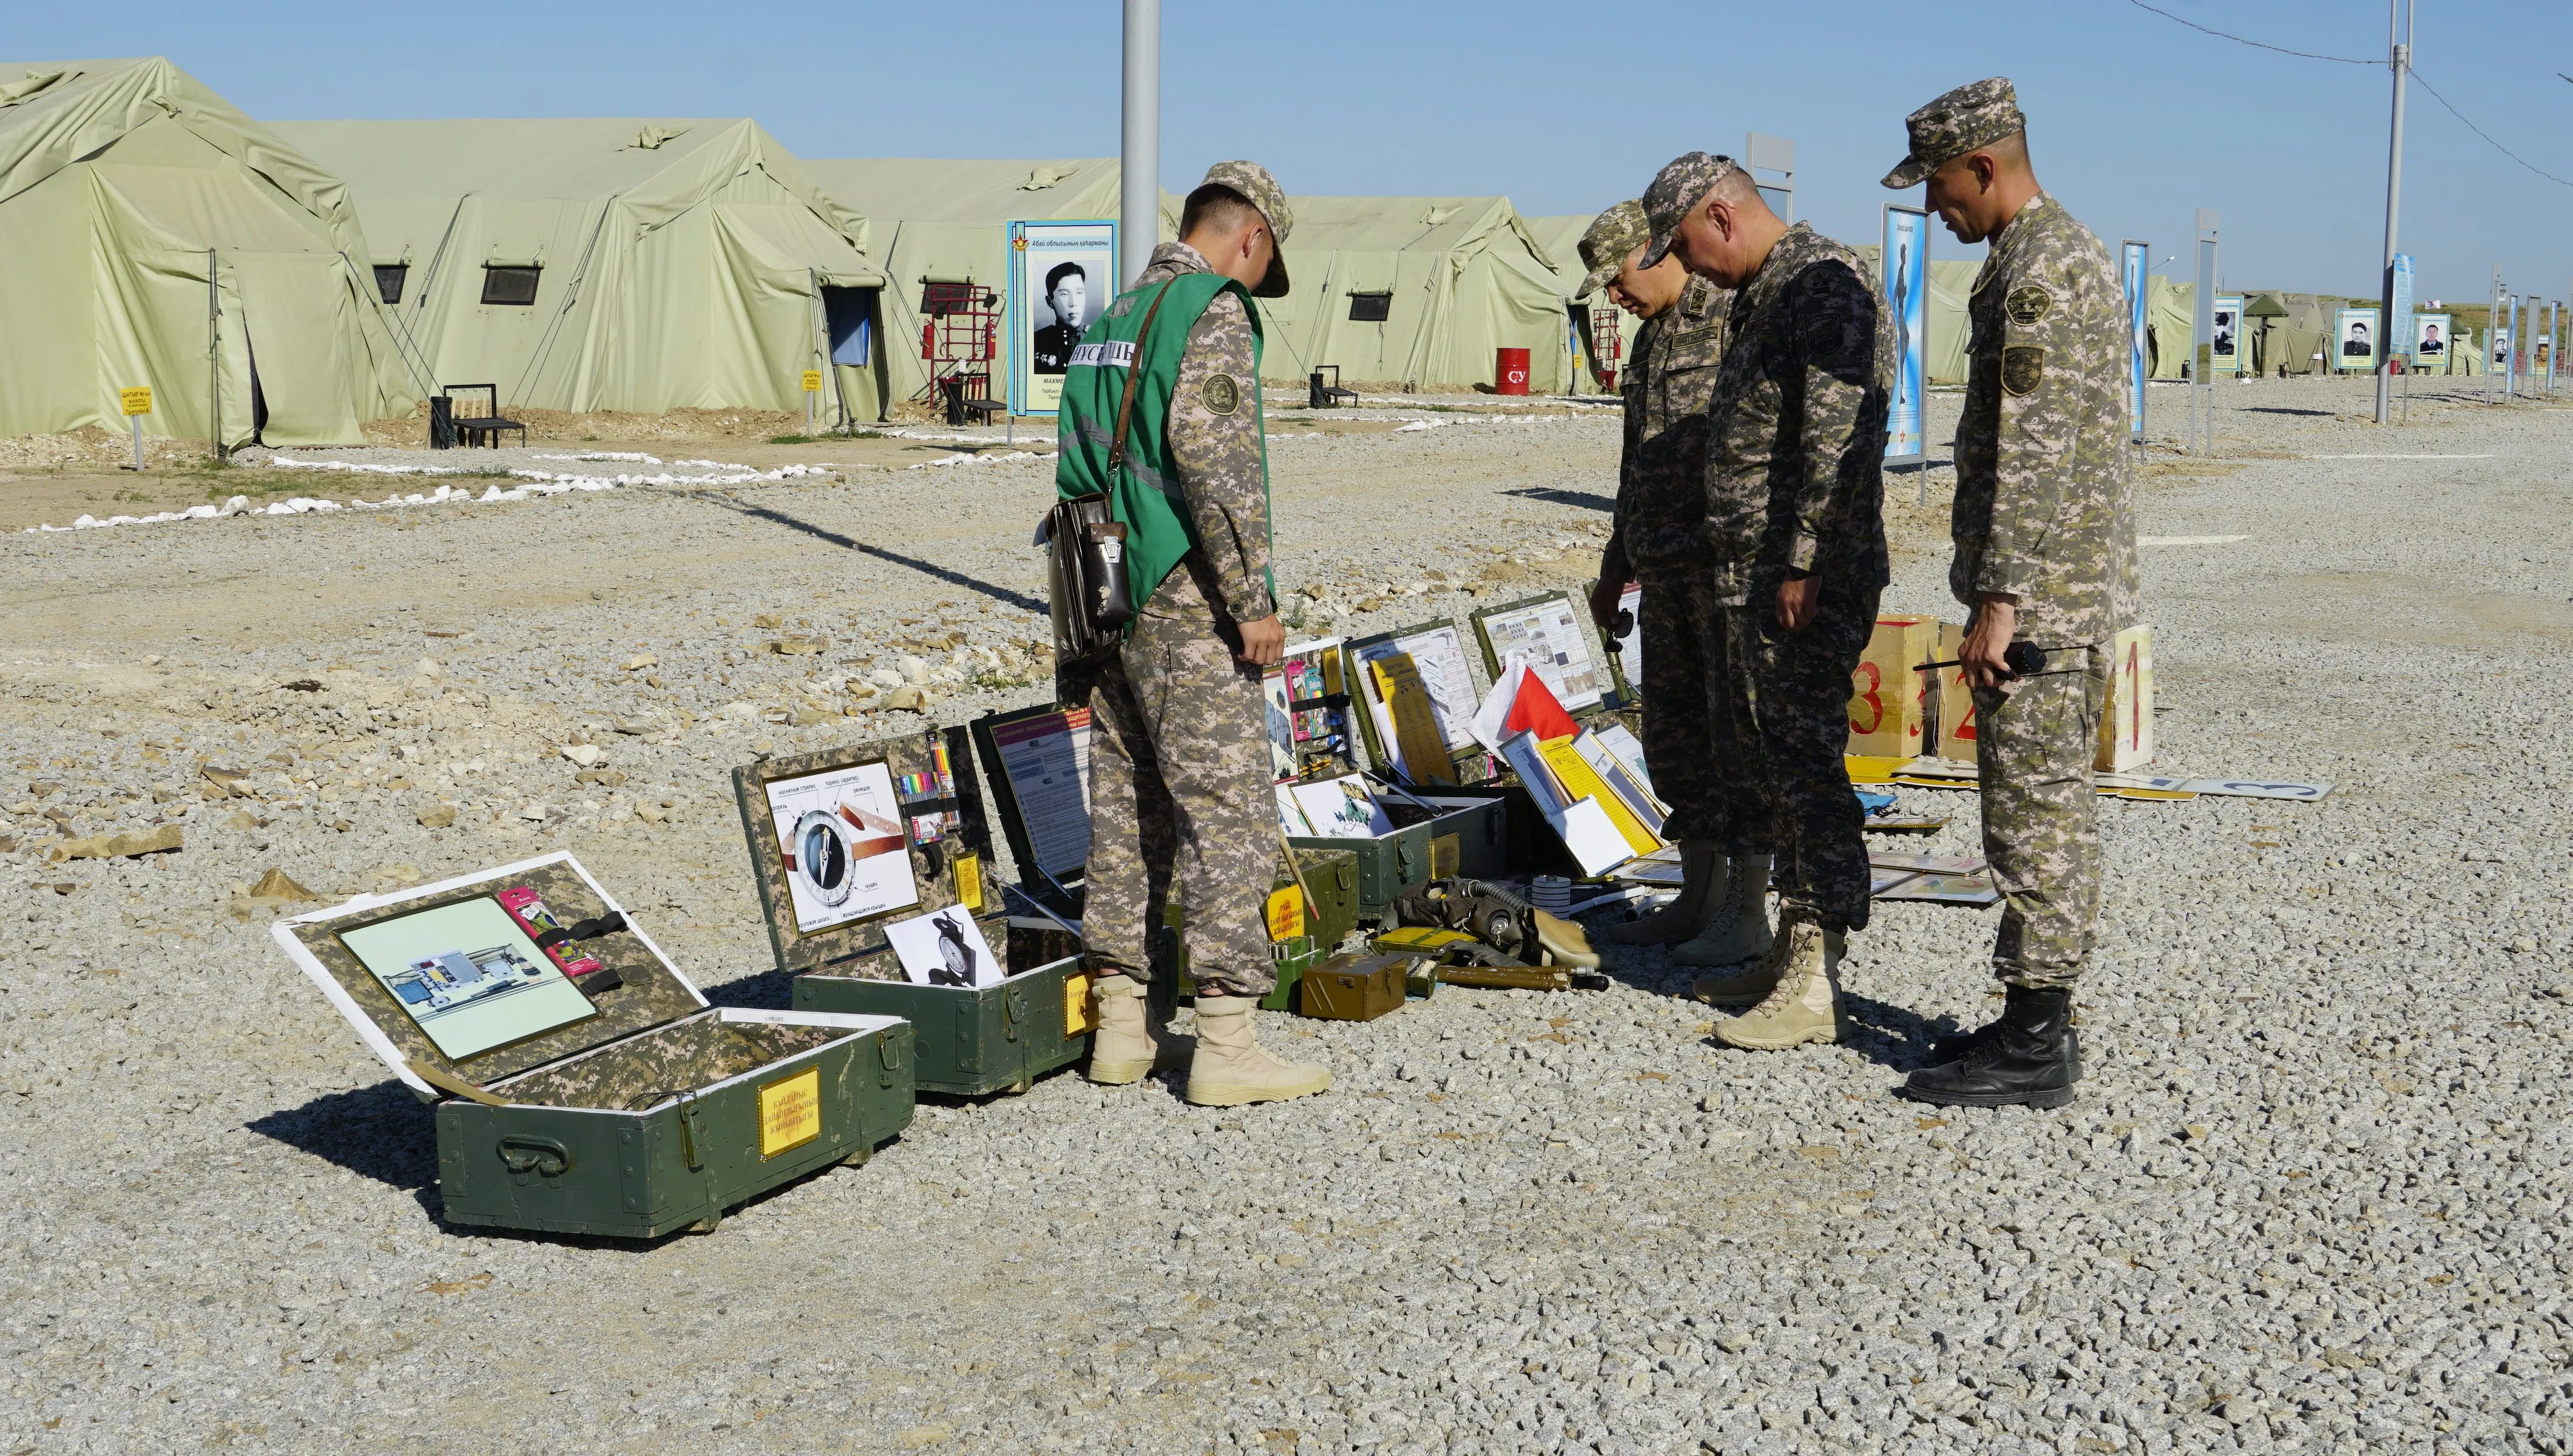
top-left (803, 157), bottom-right (1127, 416)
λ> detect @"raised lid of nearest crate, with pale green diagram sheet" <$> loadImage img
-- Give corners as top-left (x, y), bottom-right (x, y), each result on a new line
top-left (270, 852), bottom-right (705, 1099)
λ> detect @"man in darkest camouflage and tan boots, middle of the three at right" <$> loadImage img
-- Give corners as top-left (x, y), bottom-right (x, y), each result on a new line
top-left (1644, 152), bottom-right (1894, 1050)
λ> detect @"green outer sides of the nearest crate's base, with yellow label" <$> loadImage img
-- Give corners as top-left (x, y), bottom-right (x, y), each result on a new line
top-left (435, 1026), bottom-right (913, 1238)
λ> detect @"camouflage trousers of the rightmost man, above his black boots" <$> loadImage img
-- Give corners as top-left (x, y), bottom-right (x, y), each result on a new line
top-left (1973, 651), bottom-right (2108, 988)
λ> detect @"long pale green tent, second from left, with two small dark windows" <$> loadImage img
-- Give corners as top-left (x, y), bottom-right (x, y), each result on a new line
top-left (276, 118), bottom-right (882, 417)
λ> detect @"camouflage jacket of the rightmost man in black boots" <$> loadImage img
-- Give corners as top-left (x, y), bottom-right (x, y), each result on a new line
top-left (1948, 193), bottom-right (2135, 645)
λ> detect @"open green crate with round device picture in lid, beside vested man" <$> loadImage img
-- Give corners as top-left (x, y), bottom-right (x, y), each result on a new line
top-left (733, 728), bottom-right (1091, 1096)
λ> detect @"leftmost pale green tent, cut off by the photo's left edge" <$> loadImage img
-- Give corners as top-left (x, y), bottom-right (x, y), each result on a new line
top-left (0, 56), bottom-right (419, 445)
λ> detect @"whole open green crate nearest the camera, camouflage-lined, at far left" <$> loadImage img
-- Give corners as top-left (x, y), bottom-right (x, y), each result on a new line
top-left (272, 854), bottom-right (913, 1238)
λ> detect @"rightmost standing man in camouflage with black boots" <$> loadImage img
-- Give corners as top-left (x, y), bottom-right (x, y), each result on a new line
top-left (1886, 77), bottom-right (2135, 1106)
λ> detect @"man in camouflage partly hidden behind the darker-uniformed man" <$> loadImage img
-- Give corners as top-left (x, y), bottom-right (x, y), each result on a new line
top-left (1575, 203), bottom-right (1770, 965)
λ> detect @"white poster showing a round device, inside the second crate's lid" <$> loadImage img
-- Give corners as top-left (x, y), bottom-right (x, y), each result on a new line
top-left (764, 759), bottom-right (921, 936)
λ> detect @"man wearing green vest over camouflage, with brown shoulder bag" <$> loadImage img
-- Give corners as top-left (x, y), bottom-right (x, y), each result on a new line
top-left (1055, 162), bottom-right (1330, 1106)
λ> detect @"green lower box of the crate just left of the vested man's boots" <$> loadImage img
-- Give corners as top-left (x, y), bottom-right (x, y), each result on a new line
top-left (790, 960), bottom-right (1091, 1096)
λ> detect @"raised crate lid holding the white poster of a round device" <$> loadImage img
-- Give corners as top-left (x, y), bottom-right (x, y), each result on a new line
top-left (733, 728), bottom-right (990, 975)
